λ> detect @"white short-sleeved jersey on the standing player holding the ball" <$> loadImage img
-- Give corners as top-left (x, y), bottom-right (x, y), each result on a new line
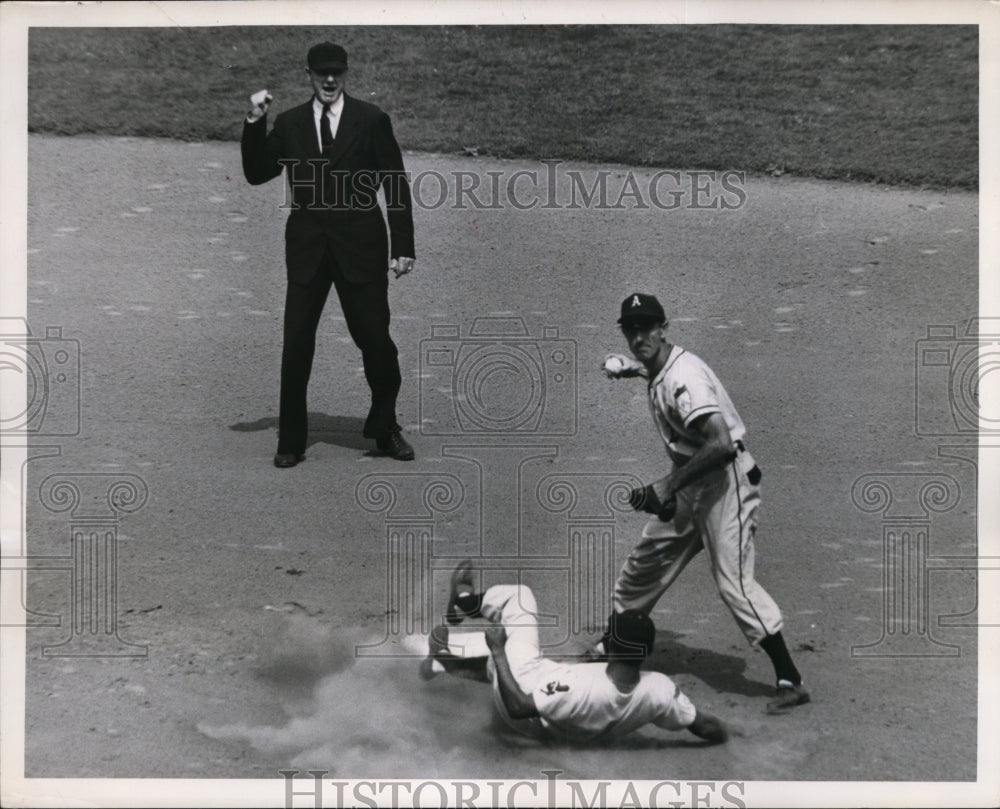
top-left (649, 346), bottom-right (746, 460)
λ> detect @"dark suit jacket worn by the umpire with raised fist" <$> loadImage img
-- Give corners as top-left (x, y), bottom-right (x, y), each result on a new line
top-left (240, 93), bottom-right (415, 284)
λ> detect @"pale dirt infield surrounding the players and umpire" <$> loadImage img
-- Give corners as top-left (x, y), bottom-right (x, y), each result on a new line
top-left (17, 136), bottom-right (978, 782)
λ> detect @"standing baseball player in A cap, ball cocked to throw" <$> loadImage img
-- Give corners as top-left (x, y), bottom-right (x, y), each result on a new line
top-left (599, 293), bottom-right (809, 713)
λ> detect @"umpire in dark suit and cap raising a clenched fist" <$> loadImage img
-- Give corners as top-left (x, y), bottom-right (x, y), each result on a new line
top-left (240, 42), bottom-right (414, 468)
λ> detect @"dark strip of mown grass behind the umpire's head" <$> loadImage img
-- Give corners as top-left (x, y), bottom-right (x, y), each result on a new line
top-left (28, 25), bottom-right (978, 188)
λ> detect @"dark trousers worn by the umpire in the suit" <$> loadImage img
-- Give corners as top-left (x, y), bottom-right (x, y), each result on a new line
top-left (278, 254), bottom-right (401, 453)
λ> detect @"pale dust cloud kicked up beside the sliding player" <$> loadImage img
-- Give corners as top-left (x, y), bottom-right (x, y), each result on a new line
top-left (198, 612), bottom-right (520, 778)
